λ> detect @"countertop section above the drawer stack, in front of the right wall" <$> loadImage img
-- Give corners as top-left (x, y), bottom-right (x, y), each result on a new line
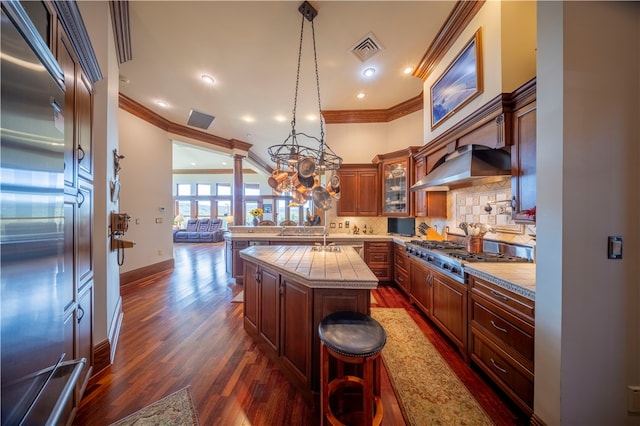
top-left (464, 262), bottom-right (536, 300)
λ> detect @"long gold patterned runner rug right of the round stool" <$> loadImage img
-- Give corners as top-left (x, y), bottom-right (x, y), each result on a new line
top-left (371, 308), bottom-right (494, 426)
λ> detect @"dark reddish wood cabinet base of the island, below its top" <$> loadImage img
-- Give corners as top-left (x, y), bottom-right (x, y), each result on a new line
top-left (244, 260), bottom-right (371, 406)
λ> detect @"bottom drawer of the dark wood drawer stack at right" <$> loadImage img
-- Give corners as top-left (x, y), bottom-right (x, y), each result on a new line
top-left (471, 331), bottom-right (534, 413)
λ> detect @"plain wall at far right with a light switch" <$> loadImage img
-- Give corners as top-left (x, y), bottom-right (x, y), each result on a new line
top-left (535, 2), bottom-right (640, 425)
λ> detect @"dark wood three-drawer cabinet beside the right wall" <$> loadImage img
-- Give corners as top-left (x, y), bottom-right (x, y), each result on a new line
top-left (469, 276), bottom-right (535, 415)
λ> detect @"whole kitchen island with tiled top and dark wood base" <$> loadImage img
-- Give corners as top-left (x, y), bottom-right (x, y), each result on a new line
top-left (239, 245), bottom-right (378, 402)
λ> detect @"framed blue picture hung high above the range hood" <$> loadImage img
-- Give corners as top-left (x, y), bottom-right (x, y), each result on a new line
top-left (431, 29), bottom-right (482, 130)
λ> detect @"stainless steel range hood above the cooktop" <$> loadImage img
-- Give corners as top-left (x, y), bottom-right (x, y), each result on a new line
top-left (411, 145), bottom-right (511, 191)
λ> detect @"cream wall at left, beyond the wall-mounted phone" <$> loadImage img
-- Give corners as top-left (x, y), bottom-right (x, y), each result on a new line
top-left (119, 110), bottom-right (174, 273)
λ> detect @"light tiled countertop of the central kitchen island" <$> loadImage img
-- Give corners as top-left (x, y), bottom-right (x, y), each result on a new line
top-left (239, 246), bottom-right (378, 289)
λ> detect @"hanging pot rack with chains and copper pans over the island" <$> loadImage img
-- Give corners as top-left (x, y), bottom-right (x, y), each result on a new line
top-left (267, 1), bottom-right (342, 211)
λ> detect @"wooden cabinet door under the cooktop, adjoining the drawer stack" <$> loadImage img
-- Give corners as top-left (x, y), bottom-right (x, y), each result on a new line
top-left (430, 271), bottom-right (467, 360)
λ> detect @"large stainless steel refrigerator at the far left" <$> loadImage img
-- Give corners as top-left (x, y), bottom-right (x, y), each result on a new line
top-left (0, 1), bottom-right (84, 425)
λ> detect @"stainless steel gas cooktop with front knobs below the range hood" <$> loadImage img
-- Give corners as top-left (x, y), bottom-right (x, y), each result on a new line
top-left (406, 240), bottom-right (532, 283)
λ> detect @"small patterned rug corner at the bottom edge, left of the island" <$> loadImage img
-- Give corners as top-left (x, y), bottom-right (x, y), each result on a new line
top-left (111, 386), bottom-right (198, 426)
